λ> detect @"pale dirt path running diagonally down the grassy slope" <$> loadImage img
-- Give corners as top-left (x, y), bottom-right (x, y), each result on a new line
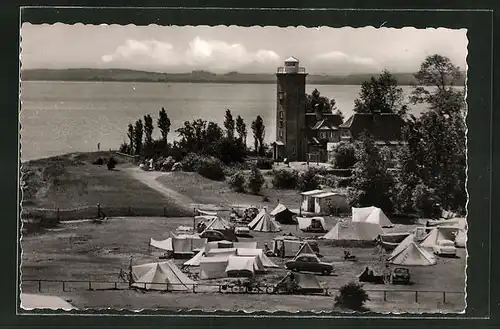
top-left (125, 167), bottom-right (199, 210)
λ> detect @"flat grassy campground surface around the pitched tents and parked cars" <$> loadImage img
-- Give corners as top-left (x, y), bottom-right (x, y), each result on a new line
top-left (21, 214), bottom-right (466, 312)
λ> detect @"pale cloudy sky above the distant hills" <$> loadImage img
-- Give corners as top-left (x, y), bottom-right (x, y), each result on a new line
top-left (20, 23), bottom-right (468, 75)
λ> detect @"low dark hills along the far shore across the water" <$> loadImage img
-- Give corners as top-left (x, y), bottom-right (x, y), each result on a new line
top-left (21, 68), bottom-right (465, 85)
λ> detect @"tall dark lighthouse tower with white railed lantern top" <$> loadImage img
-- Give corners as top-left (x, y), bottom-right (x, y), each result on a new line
top-left (273, 57), bottom-right (307, 161)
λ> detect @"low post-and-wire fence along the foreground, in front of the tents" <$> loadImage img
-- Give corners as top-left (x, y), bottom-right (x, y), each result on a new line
top-left (22, 279), bottom-right (465, 305)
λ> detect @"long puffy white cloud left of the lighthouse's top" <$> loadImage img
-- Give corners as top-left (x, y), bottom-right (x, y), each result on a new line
top-left (101, 37), bottom-right (280, 72)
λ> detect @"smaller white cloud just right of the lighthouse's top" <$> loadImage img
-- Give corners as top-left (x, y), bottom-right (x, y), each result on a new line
top-left (312, 51), bottom-right (382, 74)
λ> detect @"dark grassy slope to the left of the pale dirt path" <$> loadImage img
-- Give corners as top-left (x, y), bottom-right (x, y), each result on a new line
top-left (22, 152), bottom-right (190, 216)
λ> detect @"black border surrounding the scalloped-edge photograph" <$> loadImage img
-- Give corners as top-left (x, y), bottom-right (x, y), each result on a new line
top-left (0, 1), bottom-right (500, 328)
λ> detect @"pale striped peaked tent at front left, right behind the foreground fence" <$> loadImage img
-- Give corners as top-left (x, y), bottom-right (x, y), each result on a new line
top-left (132, 260), bottom-right (195, 291)
